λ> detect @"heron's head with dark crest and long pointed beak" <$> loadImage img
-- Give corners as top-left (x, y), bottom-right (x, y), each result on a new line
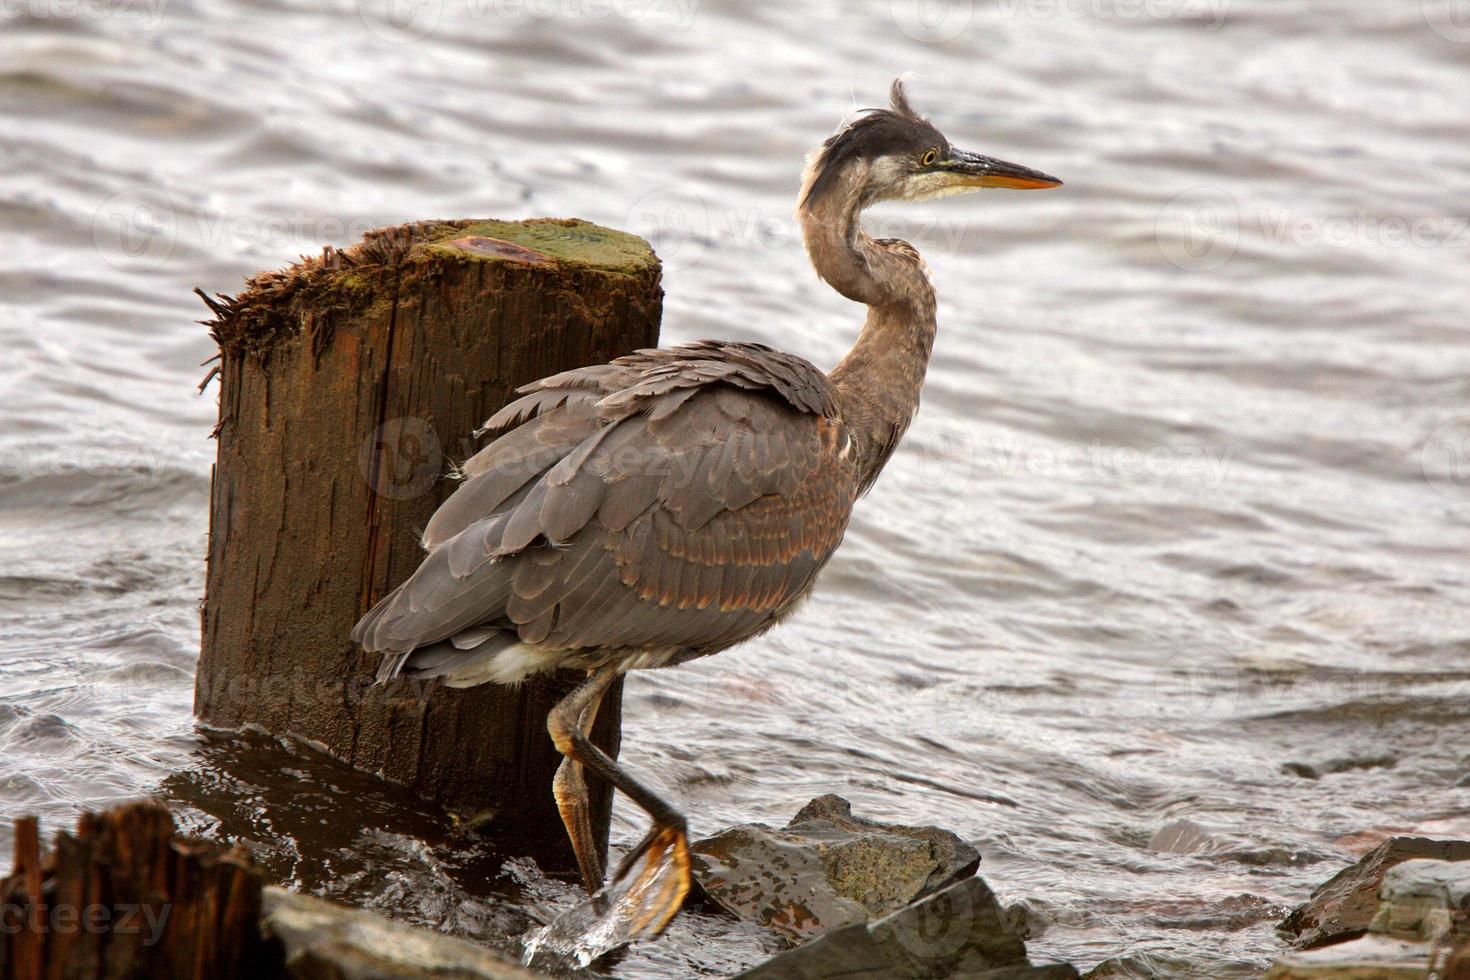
top-left (801, 79), bottom-right (1061, 209)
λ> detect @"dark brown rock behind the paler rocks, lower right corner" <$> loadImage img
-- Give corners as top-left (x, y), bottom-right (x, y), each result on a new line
top-left (1280, 837), bottom-right (1470, 948)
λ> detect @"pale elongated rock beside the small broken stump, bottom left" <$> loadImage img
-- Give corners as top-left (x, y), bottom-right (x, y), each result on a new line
top-left (260, 887), bottom-right (544, 980)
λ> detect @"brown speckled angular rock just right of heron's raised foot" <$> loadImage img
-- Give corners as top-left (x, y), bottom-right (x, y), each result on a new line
top-left (694, 795), bottom-right (980, 942)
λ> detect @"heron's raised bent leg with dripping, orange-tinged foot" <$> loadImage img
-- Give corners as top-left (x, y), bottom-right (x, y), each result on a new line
top-left (547, 664), bottom-right (689, 936)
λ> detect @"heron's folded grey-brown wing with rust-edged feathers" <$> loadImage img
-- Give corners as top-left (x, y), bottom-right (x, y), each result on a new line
top-left (353, 342), bottom-right (857, 676)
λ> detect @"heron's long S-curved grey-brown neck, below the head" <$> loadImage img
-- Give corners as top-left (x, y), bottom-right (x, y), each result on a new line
top-left (798, 173), bottom-right (936, 491)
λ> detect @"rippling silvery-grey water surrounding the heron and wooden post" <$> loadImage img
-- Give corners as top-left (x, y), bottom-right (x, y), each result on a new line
top-left (0, 0), bottom-right (1470, 977)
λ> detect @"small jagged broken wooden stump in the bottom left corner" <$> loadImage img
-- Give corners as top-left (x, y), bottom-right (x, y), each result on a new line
top-left (0, 804), bottom-right (278, 980)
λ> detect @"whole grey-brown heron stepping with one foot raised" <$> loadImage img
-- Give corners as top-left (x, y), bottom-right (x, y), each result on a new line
top-left (353, 81), bottom-right (1061, 934)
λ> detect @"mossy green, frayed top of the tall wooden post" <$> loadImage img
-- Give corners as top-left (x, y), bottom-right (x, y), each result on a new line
top-left (206, 217), bottom-right (660, 353)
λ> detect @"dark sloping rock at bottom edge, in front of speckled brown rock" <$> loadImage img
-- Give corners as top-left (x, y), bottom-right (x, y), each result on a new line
top-left (738, 877), bottom-right (1078, 980)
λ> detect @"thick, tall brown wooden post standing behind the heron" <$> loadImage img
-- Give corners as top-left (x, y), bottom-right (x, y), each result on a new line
top-left (194, 220), bottom-right (662, 870)
